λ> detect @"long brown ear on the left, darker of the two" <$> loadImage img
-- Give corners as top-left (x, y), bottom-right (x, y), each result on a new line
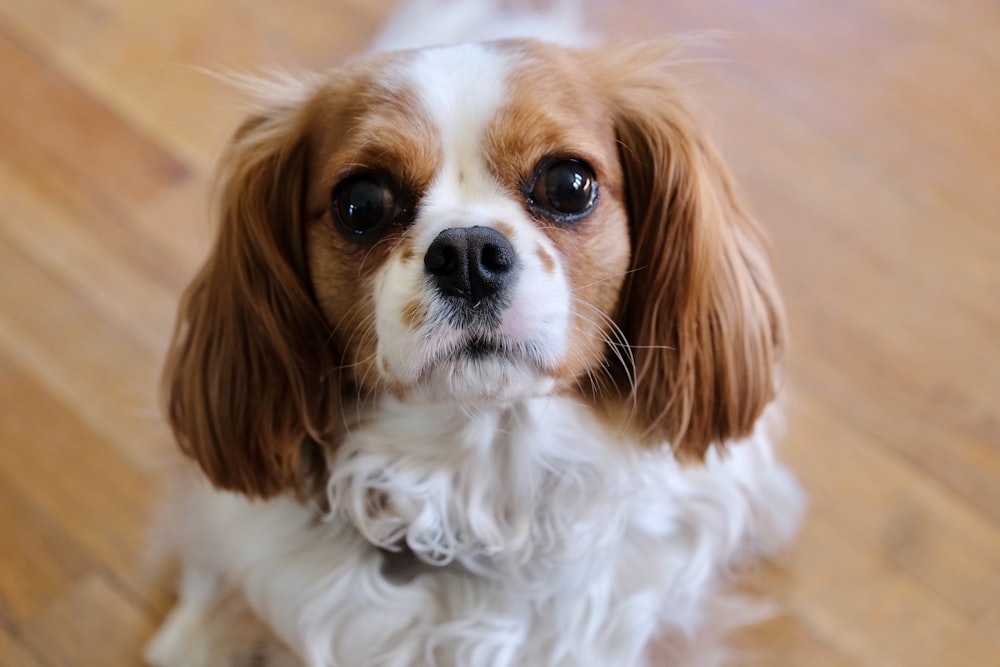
top-left (164, 88), bottom-right (337, 497)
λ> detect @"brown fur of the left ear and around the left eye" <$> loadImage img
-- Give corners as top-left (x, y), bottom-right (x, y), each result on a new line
top-left (164, 56), bottom-right (435, 498)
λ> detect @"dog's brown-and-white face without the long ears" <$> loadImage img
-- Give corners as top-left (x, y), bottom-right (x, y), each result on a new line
top-left (306, 44), bottom-right (629, 403)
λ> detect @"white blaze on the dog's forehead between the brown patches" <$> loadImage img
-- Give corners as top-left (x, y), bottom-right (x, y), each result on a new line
top-left (407, 44), bottom-right (510, 214)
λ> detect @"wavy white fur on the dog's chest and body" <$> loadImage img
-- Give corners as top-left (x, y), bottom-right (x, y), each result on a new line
top-left (154, 398), bottom-right (802, 667)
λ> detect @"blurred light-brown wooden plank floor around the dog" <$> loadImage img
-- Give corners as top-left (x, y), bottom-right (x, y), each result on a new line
top-left (0, 0), bottom-right (1000, 667)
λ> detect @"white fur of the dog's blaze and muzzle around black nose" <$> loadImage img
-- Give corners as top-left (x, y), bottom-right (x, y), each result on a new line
top-left (375, 44), bottom-right (572, 401)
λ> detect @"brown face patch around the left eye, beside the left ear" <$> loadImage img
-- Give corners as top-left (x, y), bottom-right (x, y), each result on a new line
top-left (305, 54), bottom-right (441, 389)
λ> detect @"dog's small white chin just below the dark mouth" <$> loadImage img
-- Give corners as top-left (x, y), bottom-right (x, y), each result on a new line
top-left (405, 338), bottom-right (556, 405)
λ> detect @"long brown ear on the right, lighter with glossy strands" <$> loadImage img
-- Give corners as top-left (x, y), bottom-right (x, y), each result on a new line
top-left (596, 41), bottom-right (785, 458)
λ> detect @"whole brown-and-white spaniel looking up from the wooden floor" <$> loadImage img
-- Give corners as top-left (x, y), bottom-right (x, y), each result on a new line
top-left (146, 1), bottom-right (803, 667)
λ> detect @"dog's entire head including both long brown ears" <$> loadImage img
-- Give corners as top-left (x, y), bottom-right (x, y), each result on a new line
top-left (166, 41), bottom-right (783, 497)
